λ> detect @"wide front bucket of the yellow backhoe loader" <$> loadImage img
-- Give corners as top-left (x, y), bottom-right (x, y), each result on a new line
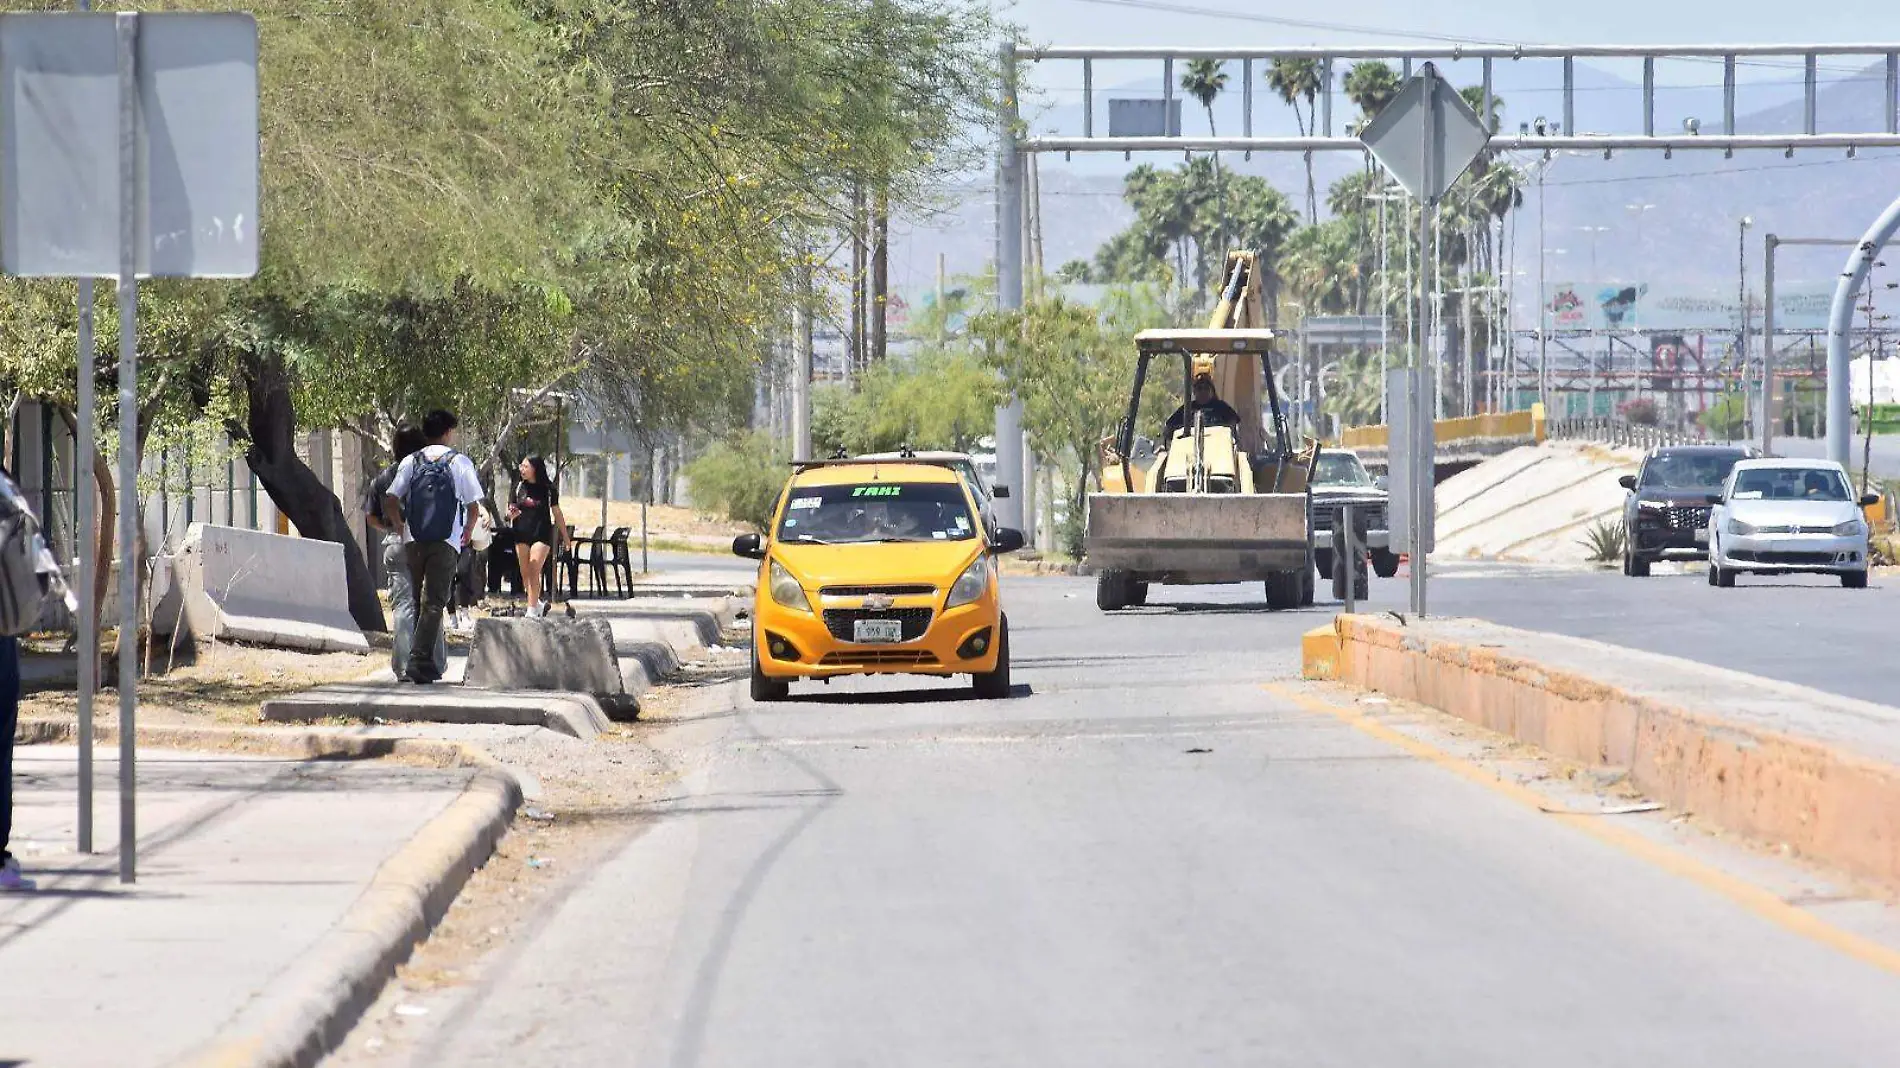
top-left (1085, 494), bottom-right (1307, 583)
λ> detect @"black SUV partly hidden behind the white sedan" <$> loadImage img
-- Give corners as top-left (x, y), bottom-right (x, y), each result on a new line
top-left (1617, 445), bottom-right (1761, 578)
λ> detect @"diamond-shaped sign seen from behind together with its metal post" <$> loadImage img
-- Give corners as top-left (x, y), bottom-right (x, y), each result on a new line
top-left (1360, 63), bottom-right (1492, 616)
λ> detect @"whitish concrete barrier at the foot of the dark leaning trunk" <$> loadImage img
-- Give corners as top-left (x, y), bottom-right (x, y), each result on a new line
top-left (152, 523), bottom-right (369, 652)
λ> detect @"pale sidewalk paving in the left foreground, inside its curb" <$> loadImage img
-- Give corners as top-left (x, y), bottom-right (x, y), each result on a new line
top-left (0, 745), bottom-right (475, 1068)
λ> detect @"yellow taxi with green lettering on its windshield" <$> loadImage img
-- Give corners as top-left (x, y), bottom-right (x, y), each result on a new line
top-left (732, 460), bottom-right (1022, 701)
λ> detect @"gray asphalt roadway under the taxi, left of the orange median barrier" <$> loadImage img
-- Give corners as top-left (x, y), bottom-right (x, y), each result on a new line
top-left (397, 578), bottom-right (1900, 1068)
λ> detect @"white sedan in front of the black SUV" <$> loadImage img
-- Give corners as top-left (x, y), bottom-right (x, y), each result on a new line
top-left (1708, 460), bottom-right (1877, 589)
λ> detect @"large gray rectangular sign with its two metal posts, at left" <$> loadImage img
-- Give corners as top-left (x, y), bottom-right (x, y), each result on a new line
top-left (0, 11), bottom-right (258, 882)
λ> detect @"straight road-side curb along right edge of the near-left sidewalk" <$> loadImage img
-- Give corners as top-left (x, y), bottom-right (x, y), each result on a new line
top-left (179, 768), bottom-right (521, 1068)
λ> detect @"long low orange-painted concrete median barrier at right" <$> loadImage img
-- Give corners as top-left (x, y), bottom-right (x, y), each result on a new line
top-left (1309, 616), bottom-right (1900, 891)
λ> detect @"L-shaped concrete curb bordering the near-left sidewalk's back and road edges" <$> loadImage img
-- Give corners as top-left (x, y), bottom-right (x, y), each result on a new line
top-left (17, 720), bottom-right (523, 1068)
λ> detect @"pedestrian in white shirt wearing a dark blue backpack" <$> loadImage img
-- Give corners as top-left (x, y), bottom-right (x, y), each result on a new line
top-left (382, 409), bottom-right (481, 684)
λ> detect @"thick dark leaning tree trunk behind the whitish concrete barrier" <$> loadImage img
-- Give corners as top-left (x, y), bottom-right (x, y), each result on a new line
top-left (243, 353), bottom-right (390, 631)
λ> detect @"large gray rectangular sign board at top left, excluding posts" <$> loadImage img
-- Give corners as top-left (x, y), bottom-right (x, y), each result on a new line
top-left (0, 11), bottom-right (258, 277)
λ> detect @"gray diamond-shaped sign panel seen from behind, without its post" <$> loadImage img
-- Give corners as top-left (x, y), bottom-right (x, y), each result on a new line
top-left (1359, 63), bottom-right (1492, 201)
